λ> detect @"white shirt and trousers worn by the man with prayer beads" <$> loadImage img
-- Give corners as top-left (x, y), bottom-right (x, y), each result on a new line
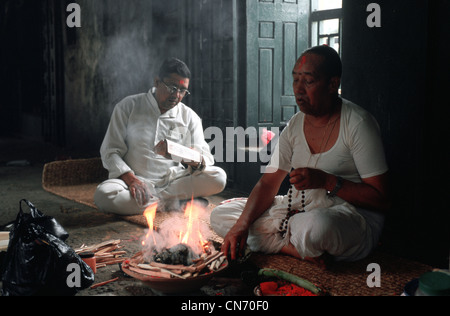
top-left (211, 100), bottom-right (388, 261)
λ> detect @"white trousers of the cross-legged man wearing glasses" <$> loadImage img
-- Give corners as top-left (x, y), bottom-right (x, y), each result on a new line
top-left (94, 166), bottom-right (227, 215)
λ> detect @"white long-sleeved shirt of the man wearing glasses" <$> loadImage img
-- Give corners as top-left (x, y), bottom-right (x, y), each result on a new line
top-left (100, 87), bottom-right (214, 190)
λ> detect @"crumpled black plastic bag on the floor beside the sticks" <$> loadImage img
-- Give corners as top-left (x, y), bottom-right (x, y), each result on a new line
top-left (2, 200), bottom-right (94, 296)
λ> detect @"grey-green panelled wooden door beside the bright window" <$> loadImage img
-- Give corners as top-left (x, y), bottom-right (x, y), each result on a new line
top-left (246, 0), bottom-right (310, 128)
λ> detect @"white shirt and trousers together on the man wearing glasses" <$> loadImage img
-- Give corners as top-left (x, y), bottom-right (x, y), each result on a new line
top-left (94, 91), bottom-right (227, 215)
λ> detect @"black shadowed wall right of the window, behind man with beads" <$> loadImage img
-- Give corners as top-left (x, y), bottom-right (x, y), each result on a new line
top-left (342, 0), bottom-right (450, 263)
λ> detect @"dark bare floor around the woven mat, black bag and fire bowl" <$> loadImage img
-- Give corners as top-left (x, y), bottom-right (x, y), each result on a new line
top-left (0, 138), bottom-right (252, 296)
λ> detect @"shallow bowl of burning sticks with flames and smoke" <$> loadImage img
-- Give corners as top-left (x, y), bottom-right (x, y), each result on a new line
top-left (122, 201), bottom-right (228, 293)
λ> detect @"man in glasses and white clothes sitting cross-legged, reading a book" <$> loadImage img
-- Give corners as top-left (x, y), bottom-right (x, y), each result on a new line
top-left (94, 58), bottom-right (226, 215)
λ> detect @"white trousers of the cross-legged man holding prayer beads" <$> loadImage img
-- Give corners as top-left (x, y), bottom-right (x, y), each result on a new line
top-left (211, 190), bottom-right (384, 261)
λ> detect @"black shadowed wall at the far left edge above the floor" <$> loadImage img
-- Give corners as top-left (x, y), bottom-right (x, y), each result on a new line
top-left (0, 0), bottom-right (43, 137)
